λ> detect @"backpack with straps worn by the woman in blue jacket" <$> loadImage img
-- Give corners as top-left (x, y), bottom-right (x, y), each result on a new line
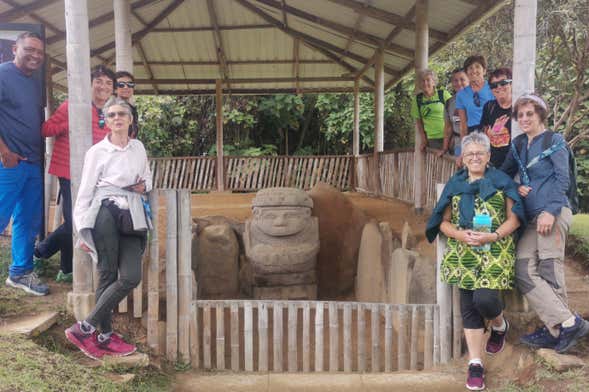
top-left (511, 131), bottom-right (579, 214)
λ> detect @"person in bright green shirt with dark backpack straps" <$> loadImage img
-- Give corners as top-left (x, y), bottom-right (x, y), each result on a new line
top-left (411, 69), bottom-right (452, 151)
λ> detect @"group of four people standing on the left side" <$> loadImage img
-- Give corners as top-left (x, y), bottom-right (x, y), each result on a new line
top-left (0, 32), bottom-right (151, 359)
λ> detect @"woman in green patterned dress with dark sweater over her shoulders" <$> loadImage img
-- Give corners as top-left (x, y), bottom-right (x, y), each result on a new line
top-left (426, 132), bottom-right (525, 390)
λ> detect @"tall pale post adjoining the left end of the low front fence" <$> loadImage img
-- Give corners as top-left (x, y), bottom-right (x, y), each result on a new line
top-left (177, 189), bottom-right (191, 363)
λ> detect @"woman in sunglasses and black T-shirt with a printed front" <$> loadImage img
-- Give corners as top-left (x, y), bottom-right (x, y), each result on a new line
top-left (481, 68), bottom-right (511, 168)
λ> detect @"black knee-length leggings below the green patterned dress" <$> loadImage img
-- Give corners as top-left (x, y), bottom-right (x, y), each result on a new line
top-left (460, 289), bottom-right (503, 329)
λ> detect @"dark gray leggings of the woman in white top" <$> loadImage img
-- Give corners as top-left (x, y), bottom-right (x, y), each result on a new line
top-left (86, 206), bottom-right (146, 333)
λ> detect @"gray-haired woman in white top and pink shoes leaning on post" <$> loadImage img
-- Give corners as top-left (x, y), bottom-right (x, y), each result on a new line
top-left (65, 97), bottom-right (151, 359)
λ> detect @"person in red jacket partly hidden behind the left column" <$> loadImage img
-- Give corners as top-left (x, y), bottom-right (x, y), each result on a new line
top-left (35, 65), bottom-right (115, 283)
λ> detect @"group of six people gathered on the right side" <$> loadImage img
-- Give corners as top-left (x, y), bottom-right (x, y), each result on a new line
top-left (422, 56), bottom-right (589, 390)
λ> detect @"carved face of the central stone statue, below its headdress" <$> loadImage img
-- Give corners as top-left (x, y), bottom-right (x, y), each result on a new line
top-left (252, 206), bottom-right (311, 237)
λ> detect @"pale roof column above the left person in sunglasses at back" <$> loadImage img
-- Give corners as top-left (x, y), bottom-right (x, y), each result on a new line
top-left (113, 0), bottom-right (133, 73)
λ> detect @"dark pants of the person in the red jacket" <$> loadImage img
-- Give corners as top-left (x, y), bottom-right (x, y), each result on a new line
top-left (35, 177), bottom-right (73, 274)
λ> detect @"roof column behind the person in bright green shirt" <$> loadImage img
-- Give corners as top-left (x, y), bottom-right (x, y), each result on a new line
top-left (413, 0), bottom-right (429, 214)
